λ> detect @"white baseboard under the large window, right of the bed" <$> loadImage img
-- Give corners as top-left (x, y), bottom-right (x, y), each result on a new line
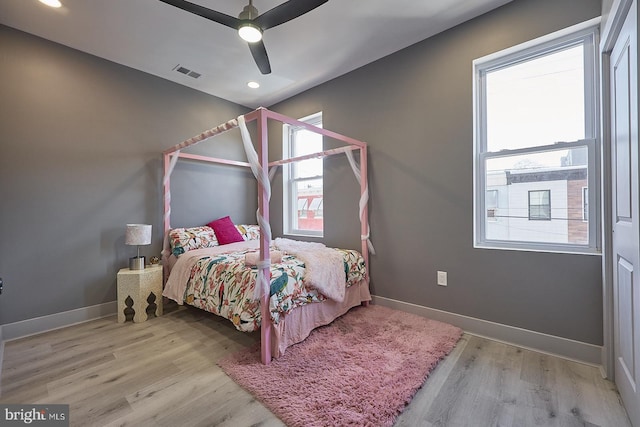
top-left (372, 295), bottom-right (602, 367)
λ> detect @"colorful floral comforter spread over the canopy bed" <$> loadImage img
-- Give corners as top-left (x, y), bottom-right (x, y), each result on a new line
top-left (164, 241), bottom-right (366, 332)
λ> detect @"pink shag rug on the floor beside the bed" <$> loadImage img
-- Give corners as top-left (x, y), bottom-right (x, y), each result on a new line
top-left (219, 305), bottom-right (462, 427)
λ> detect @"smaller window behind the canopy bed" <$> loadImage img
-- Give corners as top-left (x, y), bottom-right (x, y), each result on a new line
top-left (283, 113), bottom-right (324, 236)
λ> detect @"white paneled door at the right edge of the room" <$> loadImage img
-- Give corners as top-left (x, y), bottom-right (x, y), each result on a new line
top-left (609, 0), bottom-right (640, 426)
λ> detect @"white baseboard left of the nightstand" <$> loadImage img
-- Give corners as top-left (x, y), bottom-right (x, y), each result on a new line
top-left (2, 301), bottom-right (118, 341)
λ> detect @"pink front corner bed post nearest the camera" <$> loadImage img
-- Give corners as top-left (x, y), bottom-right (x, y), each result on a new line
top-left (257, 108), bottom-right (271, 365)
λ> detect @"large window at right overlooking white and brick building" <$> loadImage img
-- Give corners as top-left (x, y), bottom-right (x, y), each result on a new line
top-left (473, 20), bottom-right (600, 253)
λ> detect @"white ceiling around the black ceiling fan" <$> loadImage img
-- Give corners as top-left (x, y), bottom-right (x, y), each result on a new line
top-left (0, 0), bottom-right (511, 108)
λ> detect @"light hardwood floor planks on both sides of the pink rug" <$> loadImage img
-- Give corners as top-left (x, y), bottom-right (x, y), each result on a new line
top-left (0, 307), bottom-right (630, 427)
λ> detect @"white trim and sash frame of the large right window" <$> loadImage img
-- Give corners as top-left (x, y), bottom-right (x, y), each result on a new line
top-left (472, 17), bottom-right (601, 255)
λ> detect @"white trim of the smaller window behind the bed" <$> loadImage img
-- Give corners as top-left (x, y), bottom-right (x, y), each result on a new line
top-left (282, 111), bottom-right (324, 237)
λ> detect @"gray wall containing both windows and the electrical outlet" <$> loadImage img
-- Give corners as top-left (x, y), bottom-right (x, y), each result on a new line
top-left (273, 0), bottom-right (602, 344)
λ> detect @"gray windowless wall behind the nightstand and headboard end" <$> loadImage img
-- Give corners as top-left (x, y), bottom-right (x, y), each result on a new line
top-left (0, 26), bottom-right (256, 324)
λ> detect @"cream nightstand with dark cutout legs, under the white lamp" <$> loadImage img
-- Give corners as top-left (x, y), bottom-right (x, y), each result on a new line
top-left (118, 265), bottom-right (162, 323)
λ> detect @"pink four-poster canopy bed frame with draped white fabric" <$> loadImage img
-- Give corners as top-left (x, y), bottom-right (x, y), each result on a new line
top-left (163, 107), bottom-right (373, 364)
